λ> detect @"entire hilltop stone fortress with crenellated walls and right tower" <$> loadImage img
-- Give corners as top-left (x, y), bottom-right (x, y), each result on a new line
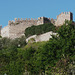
top-left (0, 12), bottom-right (73, 39)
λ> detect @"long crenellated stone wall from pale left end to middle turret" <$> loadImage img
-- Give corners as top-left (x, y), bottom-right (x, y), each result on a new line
top-left (1, 17), bottom-right (50, 39)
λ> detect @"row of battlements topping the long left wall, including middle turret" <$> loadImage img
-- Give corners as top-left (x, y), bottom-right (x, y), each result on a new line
top-left (8, 17), bottom-right (52, 25)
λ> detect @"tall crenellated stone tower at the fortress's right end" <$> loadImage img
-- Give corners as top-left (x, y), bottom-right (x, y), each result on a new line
top-left (55, 12), bottom-right (73, 26)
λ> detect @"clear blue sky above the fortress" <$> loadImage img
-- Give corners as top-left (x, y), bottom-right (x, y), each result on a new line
top-left (0, 0), bottom-right (75, 27)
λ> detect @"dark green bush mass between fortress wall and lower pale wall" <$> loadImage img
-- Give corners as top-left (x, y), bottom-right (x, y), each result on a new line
top-left (25, 23), bottom-right (55, 37)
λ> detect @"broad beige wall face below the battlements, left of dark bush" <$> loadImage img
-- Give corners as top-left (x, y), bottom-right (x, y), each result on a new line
top-left (9, 21), bottom-right (37, 39)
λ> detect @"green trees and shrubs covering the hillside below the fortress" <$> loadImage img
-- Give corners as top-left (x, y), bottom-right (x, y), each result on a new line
top-left (0, 22), bottom-right (75, 75)
